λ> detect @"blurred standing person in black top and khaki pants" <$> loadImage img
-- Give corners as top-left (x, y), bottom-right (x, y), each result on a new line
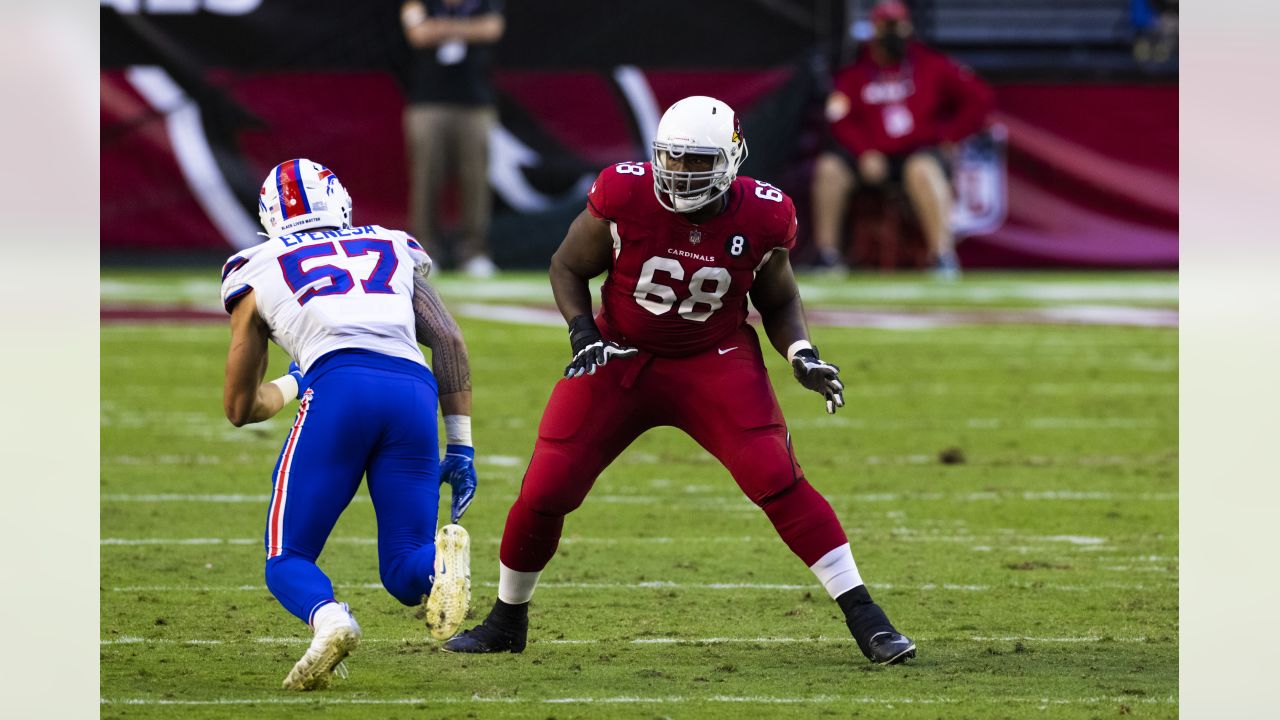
top-left (401, 0), bottom-right (504, 277)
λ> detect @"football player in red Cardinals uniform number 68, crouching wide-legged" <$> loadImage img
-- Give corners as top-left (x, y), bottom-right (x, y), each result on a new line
top-left (444, 96), bottom-right (915, 664)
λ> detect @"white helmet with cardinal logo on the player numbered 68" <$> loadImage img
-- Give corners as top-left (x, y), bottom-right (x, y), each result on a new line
top-left (653, 95), bottom-right (746, 213)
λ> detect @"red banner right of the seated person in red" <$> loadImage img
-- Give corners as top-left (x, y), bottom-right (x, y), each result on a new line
top-left (960, 85), bottom-right (1178, 269)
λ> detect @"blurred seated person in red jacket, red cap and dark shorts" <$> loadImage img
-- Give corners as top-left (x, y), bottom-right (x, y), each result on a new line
top-left (813, 0), bottom-right (993, 277)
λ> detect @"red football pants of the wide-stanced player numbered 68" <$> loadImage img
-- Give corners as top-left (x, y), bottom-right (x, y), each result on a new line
top-left (500, 325), bottom-right (849, 573)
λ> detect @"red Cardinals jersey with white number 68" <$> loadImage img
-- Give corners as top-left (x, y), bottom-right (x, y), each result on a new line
top-left (586, 163), bottom-right (796, 357)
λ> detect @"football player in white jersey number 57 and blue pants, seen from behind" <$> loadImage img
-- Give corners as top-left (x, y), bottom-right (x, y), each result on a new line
top-left (221, 159), bottom-right (476, 691)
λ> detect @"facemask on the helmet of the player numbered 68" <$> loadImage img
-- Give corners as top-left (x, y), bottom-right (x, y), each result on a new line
top-left (653, 141), bottom-right (737, 213)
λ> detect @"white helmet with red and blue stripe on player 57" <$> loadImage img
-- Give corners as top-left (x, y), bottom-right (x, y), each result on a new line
top-left (257, 158), bottom-right (351, 237)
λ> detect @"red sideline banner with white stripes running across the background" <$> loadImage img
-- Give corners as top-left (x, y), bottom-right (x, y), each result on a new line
top-left (101, 67), bottom-right (1178, 268)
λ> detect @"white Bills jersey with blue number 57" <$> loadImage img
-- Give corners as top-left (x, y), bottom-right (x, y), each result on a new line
top-left (223, 225), bottom-right (431, 373)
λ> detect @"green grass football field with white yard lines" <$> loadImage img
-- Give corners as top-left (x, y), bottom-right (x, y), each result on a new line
top-left (101, 268), bottom-right (1178, 719)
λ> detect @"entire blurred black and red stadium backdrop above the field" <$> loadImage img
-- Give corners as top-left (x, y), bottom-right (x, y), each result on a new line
top-left (101, 0), bottom-right (1178, 269)
